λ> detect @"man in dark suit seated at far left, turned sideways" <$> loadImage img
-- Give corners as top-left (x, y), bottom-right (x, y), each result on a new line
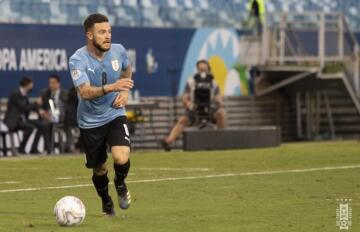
top-left (4, 76), bottom-right (46, 153)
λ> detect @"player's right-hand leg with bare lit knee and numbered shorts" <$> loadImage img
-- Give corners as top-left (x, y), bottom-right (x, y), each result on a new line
top-left (108, 116), bottom-right (131, 209)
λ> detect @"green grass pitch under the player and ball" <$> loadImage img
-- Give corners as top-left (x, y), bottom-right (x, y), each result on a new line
top-left (0, 141), bottom-right (360, 232)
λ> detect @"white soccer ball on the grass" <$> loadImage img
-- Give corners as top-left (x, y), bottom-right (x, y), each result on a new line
top-left (54, 196), bottom-right (85, 226)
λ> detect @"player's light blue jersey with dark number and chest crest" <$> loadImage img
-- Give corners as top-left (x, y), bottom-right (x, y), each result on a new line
top-left (69, 44), bottom-right (130, 128)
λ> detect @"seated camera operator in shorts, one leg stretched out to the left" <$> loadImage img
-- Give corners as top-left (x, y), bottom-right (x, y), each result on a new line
top-left (161, 60), bottom-right (225, 151)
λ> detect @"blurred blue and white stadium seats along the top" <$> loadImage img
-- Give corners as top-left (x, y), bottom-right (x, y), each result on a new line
top-left (0, 0), bottom-right (360, 30)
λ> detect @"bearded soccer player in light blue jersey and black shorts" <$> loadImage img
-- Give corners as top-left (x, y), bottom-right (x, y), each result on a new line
top-left (69, 14), bottom-right (133, 216)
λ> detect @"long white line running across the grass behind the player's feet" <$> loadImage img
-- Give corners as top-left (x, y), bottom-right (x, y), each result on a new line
top-left (0, 165), bottom-right (360, 193)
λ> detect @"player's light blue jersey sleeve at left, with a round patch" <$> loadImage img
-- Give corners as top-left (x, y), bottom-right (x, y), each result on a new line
top-left (69, 57), bottom-right (90, 87)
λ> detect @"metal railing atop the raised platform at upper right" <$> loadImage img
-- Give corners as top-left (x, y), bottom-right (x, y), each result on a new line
top-left (262, 12), bottom-right (360, 96)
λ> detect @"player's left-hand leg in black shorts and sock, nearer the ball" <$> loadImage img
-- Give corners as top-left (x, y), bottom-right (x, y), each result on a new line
top-left (80, 126), bottom-right (115, 216)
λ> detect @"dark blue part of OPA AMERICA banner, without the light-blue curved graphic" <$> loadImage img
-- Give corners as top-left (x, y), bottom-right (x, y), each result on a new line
top-left (0, 24), bottom-right (195, 97)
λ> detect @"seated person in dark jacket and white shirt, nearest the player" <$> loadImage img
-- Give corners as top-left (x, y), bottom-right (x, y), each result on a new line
top-left (38, 74), bottom-right (68, 153)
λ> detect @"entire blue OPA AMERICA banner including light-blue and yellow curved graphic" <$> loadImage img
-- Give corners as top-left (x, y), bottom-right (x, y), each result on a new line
top-left (0, 24), bottom-right (249, 97)
